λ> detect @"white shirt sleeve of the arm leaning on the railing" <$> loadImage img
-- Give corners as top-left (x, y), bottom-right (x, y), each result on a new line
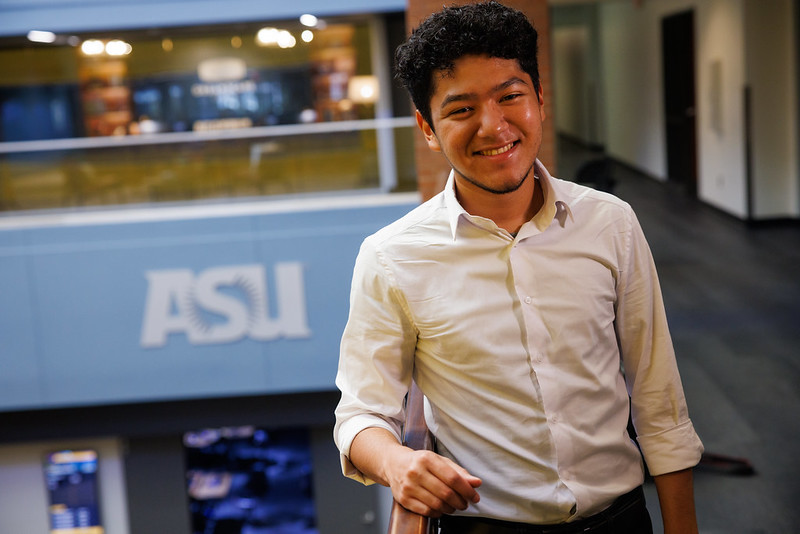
top-left (334, 238), bottom-right (416, 484)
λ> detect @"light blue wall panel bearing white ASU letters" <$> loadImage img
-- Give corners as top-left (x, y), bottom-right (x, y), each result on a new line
top-left (0, 196), bottom-right (416, 410)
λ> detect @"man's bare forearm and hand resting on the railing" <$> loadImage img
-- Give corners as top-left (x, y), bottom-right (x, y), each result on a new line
top-left (350, 428), bottom-right (481, 517)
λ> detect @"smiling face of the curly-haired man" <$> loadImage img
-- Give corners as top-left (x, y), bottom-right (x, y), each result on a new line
top-left (417, 55), bottom-right (544, 194)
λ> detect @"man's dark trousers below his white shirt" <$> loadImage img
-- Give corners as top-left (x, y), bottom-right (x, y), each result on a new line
top-left (439, 487), bottom-right (653, 534)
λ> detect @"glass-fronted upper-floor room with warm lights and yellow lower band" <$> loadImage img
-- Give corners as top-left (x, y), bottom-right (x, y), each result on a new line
top-left (0, 14), bottom-right (416, 214)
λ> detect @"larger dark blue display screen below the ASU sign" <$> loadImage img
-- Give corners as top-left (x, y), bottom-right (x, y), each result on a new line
top-left (184, 426), bottom-right (319, 534)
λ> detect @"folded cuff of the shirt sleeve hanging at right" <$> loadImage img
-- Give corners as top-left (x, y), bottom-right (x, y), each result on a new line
top-left (637, 420), bottom-right (703, 476)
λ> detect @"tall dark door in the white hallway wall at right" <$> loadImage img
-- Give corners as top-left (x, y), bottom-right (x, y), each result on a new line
top-left (661, 11), bottom-right (697, 196)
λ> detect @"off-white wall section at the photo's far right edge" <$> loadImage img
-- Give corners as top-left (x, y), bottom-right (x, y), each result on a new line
top-left (744, 0), bottom-right (798, 218)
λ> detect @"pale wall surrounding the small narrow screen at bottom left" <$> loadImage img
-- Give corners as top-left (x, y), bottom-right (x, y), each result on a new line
top-left (0, 439), bottom-right (129, 534)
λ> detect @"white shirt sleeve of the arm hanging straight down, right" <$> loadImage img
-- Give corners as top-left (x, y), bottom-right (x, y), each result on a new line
top-left (617, 211), bottom-right (703, 475)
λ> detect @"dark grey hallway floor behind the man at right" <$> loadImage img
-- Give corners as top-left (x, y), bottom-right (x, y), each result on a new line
top-left (558, 139), bottom-right (800, 534)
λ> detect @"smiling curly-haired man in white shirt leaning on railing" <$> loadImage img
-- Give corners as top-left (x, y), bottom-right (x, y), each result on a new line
top-left (334, 2), bottom-right (702, 534)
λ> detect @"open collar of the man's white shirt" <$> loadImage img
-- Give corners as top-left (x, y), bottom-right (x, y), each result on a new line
top-left (444, 159), bottom-right (574, 241)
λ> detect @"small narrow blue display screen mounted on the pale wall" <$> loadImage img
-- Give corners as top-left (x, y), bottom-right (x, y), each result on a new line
top-left (44, 450), bottom-right (104, 534)
